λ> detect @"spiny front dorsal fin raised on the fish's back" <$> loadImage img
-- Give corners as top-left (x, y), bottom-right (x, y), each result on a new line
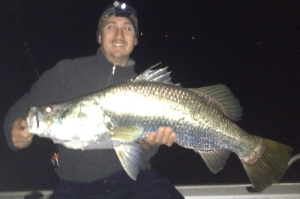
top-left (133, 62), bottom-right (173, 85)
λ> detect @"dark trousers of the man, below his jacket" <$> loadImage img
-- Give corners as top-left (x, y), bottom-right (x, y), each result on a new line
top-left (50, 169), bottom-right (184, 199)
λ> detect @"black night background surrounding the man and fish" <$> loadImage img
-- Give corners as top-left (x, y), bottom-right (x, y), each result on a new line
top-left (0, 0), bottom-right (300, 190)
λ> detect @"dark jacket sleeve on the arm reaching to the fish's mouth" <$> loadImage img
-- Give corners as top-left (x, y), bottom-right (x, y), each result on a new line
top-left (3, 62), bottom-right (64, 150)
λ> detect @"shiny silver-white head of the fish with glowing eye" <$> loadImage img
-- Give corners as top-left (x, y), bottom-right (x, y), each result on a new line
top-left (26, 100), bottom-right (107, 148)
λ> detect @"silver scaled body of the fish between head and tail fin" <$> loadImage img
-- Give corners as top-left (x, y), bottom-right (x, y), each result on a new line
top-left (98, 81), bottom-right (251, 154)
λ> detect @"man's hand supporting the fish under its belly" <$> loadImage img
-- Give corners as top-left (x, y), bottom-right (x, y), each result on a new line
top-left (140, 127), bottom-right (176, 149)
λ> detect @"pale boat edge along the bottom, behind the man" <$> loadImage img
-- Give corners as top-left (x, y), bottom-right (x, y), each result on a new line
top-left (0, 183), bottom-right (300, 199)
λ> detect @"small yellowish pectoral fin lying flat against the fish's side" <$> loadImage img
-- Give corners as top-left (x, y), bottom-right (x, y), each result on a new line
top-left (109, 126), bottom-right (144, 142)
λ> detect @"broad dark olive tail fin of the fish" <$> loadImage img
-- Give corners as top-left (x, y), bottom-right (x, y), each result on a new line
top-left (242, 138), bottom-right (293, 192)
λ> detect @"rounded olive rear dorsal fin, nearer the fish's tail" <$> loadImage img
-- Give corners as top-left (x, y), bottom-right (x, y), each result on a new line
top-left (190, 84), bottom-right (243, 121)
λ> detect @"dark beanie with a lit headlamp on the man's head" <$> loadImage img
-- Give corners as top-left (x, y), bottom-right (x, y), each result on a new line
top-left (96, 1), bottom-right (139, 39)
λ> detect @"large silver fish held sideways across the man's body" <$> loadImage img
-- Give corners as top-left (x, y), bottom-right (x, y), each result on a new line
top-left (27, 64), bottom-right (292, 191)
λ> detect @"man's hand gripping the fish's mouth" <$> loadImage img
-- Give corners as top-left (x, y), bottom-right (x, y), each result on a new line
top-left (11, 118), bottom-right (33, 149)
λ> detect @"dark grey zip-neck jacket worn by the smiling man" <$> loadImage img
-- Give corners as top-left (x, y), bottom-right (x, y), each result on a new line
top-left (4, 49), bottom-right (157, 182)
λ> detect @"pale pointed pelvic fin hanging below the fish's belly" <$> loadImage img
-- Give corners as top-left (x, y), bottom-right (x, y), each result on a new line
top-left (115, 143), bottom-right (142, 180)
